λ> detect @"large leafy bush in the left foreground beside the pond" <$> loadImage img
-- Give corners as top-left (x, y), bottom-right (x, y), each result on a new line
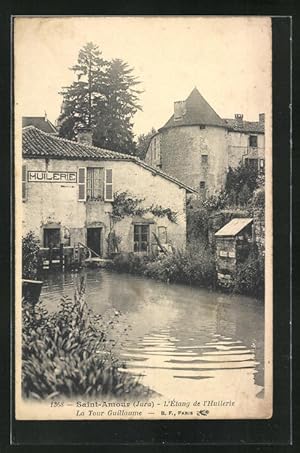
top-left (22, 278), bottom-right (151, 399)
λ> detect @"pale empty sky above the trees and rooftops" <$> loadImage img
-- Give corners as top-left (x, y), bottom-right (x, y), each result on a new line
top-left (14, 16), bottom-right (271, 135)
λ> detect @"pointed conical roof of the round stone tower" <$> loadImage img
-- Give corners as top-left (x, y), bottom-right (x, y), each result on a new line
top-left (161, 88), bottom-right (224, 129)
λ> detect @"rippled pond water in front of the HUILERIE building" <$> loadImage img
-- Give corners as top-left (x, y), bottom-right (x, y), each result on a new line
top-left (41, 269), bottom-right (264, 399)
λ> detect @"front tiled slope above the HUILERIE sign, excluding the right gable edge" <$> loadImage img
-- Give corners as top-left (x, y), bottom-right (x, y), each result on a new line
top-left (23, 126), bottom-right (130, 160)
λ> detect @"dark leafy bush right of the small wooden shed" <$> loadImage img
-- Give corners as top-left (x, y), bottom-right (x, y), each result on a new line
top-left (233, 245), bottom-right (265, 298)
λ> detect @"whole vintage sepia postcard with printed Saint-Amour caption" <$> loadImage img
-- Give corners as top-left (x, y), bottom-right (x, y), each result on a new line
top-left (13, 16), bottom-right (273, 421)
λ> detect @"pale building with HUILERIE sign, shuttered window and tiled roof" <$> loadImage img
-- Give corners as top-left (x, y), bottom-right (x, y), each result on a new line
top-left (22, 126), bottom-right (193, 258)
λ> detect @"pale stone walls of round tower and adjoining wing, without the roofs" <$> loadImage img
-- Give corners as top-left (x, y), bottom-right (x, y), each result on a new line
top-left (145, 125), bottom-right (265, 196)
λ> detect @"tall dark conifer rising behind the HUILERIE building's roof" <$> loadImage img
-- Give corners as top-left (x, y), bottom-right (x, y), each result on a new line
top-left (58, 43), bottom-right (141, 153)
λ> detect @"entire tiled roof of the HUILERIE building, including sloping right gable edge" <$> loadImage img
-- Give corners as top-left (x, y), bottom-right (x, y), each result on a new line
top-left (22, 126), bottom-right (196, 193)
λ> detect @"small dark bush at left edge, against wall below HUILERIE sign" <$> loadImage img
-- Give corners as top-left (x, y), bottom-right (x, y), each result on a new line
top-left (22, 231), bottom-right (40, 279)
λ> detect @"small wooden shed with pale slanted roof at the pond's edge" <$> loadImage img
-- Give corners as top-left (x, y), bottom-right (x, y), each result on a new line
top-left (215, 218), bottom-right (253, 287)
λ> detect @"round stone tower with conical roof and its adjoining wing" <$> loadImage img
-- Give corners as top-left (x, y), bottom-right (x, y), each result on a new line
top-left (145, 88), bottom-right (265, 196)
